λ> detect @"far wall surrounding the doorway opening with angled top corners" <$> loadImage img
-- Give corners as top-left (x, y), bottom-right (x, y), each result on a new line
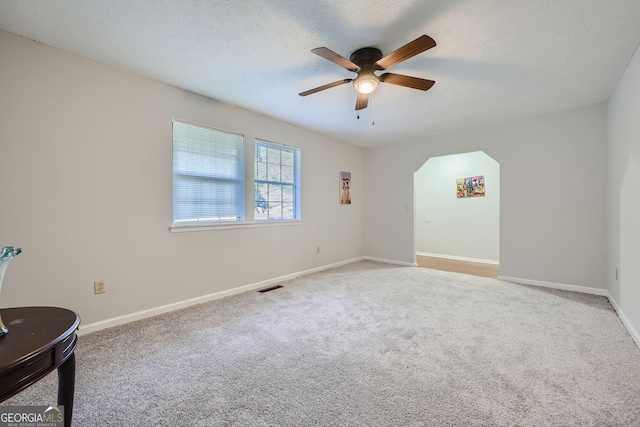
top-left (365, 104), bottom-right (607, 289)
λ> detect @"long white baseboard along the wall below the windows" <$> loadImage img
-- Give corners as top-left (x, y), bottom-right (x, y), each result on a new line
top-left (78, 257), bottom-right (365, 335)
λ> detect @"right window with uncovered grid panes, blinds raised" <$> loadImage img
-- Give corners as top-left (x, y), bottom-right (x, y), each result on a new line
top-left (254, 140), bottom-right (300, 221)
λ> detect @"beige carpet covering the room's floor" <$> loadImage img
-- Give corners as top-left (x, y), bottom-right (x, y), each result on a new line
top-left (3, 262), bottom-right (640, 427)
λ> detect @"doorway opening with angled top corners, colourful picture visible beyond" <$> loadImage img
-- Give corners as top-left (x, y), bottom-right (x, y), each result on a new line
top-left (414, 151), bottom-right (500, 277)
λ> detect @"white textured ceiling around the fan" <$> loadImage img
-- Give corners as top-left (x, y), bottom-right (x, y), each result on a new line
top-left (0, 0), bottom-right (640, 146)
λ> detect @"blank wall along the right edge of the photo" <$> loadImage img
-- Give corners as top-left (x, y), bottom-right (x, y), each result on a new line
top-left (606, 42), bottom-right (640, 345)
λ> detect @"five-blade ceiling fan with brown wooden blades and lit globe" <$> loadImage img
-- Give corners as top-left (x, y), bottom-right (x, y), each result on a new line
top-left (298, 35), bottom-right (436, 110)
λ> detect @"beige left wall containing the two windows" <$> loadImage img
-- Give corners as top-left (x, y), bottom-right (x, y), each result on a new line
top-left (0, 32), bottom-right (364, 324)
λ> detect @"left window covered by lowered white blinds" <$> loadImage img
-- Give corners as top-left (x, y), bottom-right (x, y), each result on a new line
top-left (173, 120), bottom-right (245, 226)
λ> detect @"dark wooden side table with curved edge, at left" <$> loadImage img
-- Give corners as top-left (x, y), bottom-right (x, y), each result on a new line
top-left (0, 307), bottom-right (80, 427)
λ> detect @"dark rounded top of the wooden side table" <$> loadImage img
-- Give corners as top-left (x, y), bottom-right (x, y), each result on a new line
top-left (0, 307), bottom-right (80, 372)
